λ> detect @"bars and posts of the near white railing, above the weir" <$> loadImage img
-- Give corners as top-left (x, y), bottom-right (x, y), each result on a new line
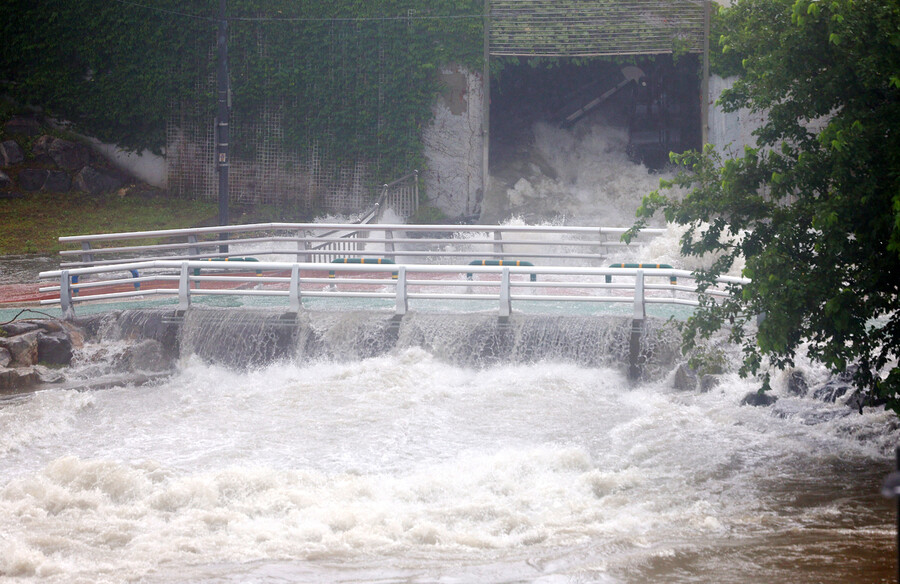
top-left (40, 260), bottom-right (749, 321)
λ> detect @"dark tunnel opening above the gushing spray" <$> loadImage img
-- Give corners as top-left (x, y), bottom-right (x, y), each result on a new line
top-left (489, 54), bottom-right (702, 175)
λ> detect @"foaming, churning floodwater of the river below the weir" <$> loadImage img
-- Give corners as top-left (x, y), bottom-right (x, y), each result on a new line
top-left (0, 121), bottom-right (900, 584)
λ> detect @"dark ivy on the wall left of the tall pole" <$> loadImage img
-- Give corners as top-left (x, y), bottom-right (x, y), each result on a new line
top-left (0, 0), bottom-right (214, 152)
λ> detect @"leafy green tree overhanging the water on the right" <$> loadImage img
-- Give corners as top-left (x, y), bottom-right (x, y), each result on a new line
top-left (624, 0), bottom-right (900, 413)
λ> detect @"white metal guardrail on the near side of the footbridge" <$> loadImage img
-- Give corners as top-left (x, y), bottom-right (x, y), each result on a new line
top-left (40, 260), bottom-right (749, 319)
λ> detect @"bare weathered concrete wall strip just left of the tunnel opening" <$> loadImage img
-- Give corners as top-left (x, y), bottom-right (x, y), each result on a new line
top-left (422, 66), bottom-right (484, 218)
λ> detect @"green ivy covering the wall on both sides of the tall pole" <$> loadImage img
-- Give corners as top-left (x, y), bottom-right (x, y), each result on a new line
top-left (0, 0), bottom-right (484, 213)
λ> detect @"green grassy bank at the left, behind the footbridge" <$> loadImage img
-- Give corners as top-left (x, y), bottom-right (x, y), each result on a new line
top-left (0, 192), bottom-right (218, 255)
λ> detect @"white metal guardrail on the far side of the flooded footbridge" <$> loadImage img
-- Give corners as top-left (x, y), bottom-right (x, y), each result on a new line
top-left (59, 223), bottom-right (664, 269)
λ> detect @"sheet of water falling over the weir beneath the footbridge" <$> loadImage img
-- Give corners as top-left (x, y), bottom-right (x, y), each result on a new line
top-left (181, 309), bottom-right (679, 378)
